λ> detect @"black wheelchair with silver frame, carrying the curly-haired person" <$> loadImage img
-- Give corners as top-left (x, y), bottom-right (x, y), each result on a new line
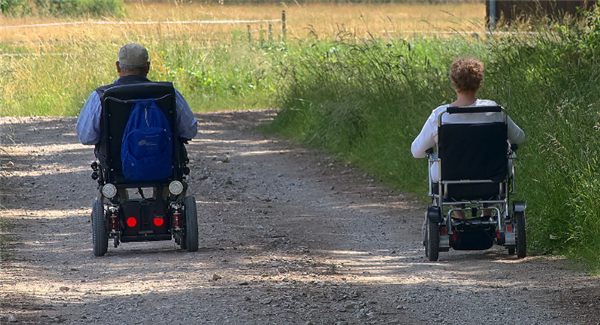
top-left (423, 106), bottom-right (527, 261)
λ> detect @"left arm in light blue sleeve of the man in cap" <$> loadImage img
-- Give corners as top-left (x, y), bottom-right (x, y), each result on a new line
top-left (75, 91), bottom-right (102, 145)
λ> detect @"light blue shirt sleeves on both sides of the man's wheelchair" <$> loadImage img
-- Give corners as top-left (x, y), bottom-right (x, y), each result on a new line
top-left (75, 84), bottom-right (198, 145)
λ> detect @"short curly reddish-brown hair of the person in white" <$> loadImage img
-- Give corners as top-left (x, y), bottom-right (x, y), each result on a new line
top-left (450, 58), bottom-right (484, 92)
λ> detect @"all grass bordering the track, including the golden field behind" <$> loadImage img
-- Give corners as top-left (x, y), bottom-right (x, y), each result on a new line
top-left (0, 2), bottom-right (600, 272)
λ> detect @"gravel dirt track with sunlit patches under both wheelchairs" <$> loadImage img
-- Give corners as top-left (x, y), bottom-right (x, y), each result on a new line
top-left (0, 111), bottom-right (600, 325)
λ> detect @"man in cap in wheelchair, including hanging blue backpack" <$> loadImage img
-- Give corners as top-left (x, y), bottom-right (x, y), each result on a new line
top-left (76, 43), bottom-right (198, 256)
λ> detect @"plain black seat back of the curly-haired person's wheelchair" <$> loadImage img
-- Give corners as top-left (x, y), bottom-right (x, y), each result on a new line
top-left (438, 106), bottom-right (508, 201)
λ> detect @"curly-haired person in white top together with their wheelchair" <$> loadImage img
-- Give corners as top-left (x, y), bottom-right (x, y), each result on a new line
top-left (411, 58), bottom-right (527, 261)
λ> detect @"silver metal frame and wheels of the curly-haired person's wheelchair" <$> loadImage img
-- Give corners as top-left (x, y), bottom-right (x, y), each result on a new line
top-left (423, 106), bottom-right (527, 261)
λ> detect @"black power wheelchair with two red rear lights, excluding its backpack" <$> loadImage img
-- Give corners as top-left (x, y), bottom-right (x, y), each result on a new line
top-left (92, 82), bottom-right (198, 256)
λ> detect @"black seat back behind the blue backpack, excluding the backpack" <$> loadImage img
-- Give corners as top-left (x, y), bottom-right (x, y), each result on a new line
top-left (100, 82), bottom-right (180, 186)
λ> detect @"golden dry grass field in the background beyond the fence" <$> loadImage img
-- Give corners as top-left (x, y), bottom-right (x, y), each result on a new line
top-left (0, 1), bottom-right (485, 42)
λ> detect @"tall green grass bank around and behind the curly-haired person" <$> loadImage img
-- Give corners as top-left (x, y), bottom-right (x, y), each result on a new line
top-left (271, 17), bottom-right (600, 272)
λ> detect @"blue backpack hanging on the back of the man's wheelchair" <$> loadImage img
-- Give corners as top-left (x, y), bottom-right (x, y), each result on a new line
top-left (121, 99), bottom-right (173, 181)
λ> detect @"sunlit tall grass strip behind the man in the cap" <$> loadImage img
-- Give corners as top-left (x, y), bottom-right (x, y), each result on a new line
top-left (0, 33), bottom-right (283, 116)
